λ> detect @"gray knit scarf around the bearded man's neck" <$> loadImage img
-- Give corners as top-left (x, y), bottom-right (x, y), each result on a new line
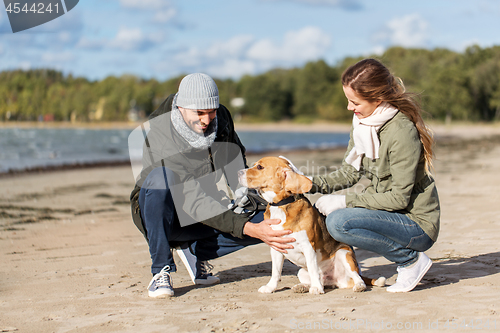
top-left (171, 96), bottom-right (217, 149)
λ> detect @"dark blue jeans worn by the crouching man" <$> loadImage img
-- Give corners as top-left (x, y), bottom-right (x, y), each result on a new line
top-left (139, 168), bottom-right (264, 275)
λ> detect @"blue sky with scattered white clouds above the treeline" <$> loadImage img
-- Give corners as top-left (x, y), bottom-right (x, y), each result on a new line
top-left (0, 0), bottom-right (500, 81)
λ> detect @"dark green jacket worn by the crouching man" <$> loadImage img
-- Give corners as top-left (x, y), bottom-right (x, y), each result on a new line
top-left (130, 95), bottom-right (248, 239)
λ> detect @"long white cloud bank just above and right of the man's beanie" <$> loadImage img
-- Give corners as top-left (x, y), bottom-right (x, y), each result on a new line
top-left (174, 27), bottom-right (331, 78)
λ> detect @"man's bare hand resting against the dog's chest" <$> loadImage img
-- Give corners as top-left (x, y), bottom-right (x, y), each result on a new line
top-left (243, 219), bottom-right (295, 253)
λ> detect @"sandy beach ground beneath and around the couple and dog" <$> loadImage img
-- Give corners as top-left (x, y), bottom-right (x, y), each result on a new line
top-left (0, 125), bottom-right (500, 332)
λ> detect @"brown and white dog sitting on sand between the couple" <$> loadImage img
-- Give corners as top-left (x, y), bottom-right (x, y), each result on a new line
top-left (238, 157), bottom-right (385, 294)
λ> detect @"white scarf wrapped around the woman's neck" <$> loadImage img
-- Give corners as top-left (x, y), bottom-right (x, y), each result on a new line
top-left (345, 102), bottom-right (398, 171)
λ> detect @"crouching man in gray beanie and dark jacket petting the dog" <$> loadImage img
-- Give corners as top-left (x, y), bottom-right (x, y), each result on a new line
top-left (131, 73), bottom-right (294, 297)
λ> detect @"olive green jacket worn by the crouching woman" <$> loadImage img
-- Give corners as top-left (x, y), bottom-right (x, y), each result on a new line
top-left (311, 112), bottom-right (440, 241)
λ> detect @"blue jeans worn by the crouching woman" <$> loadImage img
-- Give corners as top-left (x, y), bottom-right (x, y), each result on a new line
top-left (326, 208), bottom-right (434, 267)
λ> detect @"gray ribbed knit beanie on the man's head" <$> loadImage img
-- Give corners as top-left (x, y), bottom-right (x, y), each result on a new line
top-left (177, 73), bottom-right (219, 110)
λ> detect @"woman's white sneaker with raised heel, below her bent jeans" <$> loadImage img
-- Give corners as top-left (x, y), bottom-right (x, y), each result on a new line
top-left (387, 252), bottom-right (432, 293)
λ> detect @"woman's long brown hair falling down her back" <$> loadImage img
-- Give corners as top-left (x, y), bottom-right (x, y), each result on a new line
top-left (342, 59), bottom-right (434, 174)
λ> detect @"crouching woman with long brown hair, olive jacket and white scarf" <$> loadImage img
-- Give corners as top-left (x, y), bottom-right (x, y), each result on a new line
top-left (311, 59), bottom-right (440, 292)
